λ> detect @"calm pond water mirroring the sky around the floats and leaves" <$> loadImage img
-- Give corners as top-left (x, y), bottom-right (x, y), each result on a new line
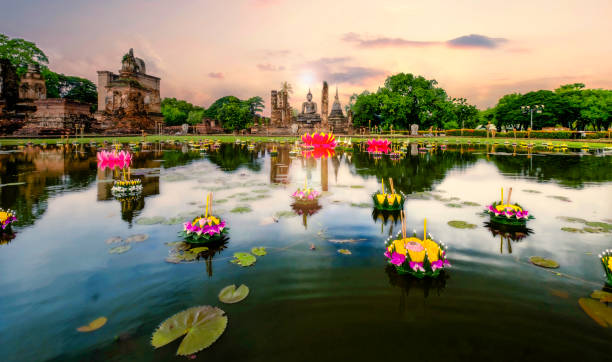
top-left (0, 144), bottom-right (612, 361)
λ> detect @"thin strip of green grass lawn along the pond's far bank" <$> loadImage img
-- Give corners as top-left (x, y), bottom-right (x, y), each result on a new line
top-left (0, 135), bottom-right (612, 148)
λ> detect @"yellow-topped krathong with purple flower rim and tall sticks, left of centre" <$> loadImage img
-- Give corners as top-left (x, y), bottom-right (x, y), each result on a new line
top-left (179, 192), bottom-right (229, 244)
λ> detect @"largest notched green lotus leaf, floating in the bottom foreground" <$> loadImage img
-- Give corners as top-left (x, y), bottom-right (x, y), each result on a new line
top-left (151, 305), bottom-right (227, 356)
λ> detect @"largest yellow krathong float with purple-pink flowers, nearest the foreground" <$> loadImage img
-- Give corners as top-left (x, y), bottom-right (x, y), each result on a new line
top-left (385, 216), bottom-right (450, 278)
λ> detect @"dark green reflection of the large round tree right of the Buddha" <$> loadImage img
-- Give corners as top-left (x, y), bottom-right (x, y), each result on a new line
top-left (351, 148), bottom-right (477, 194)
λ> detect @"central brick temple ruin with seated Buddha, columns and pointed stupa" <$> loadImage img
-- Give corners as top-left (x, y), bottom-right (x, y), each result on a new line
top-left (266, 82), bottom-right (353, 134)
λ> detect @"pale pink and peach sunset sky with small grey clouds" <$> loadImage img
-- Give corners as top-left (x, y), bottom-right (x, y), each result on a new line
top-left (0, 0), bottom-right (612, 115)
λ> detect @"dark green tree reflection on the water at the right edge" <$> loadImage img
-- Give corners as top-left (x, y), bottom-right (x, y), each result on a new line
top-left (490, 149), bottom-right (612, 188)
